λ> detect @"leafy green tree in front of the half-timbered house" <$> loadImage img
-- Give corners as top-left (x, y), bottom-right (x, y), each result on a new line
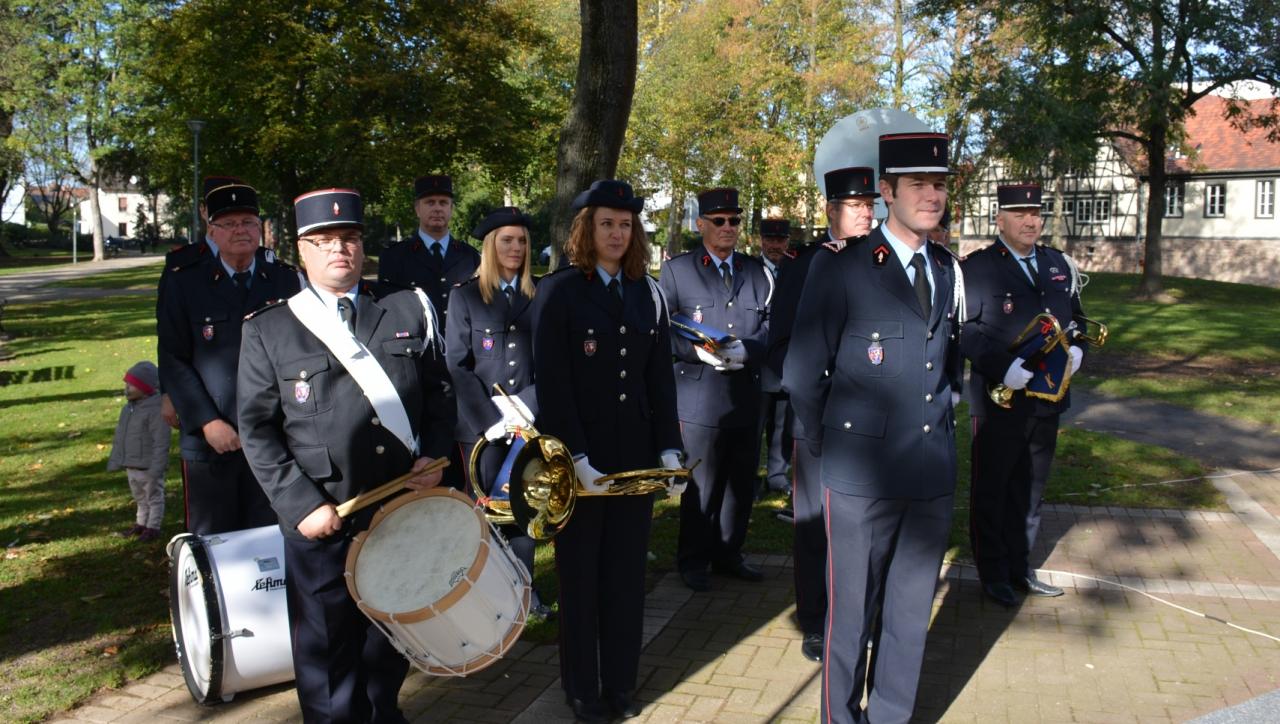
top-left (927, 0), bottom-right (1280, 297)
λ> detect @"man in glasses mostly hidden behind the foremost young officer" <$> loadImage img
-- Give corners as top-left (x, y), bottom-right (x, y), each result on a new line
top-left (767, 166), bottom-right (879, 661)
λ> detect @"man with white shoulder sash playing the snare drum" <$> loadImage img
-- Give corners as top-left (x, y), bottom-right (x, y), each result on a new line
top-left (239, 188), bottom-right (453, 721)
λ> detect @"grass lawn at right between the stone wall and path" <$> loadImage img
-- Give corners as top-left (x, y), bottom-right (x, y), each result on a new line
top-left (1073, 272), bottom-right (1280, 430)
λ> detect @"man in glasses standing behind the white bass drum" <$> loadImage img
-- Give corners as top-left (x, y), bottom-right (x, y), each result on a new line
top-left (156, 183), bottom-right (300, 535)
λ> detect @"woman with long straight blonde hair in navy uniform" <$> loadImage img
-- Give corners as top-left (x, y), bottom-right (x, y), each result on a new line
top-left (444, 206), bottom-right (550, 618)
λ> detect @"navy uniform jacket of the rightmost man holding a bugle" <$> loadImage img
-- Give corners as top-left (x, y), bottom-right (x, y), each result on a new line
top-left (961, 240), bottom-right (1084, 417)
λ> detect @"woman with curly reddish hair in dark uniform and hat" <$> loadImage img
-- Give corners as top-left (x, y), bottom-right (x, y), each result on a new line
top-left (534, 180), bottom-right (682, 721)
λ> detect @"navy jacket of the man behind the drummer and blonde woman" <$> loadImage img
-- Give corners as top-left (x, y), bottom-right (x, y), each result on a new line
top-left (378, 229), bottom-right (480, 329)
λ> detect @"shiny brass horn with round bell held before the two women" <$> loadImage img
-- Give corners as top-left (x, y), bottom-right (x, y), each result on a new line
top-left (467, 382), bottom-right (696, 541)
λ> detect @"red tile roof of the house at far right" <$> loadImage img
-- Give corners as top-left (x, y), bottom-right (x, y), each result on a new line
top-left (1166, 96), bottom-right (1280, 173)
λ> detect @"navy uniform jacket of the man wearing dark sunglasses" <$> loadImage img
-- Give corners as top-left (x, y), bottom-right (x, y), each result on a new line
top-left (662, 248), bottom-right (773, 427)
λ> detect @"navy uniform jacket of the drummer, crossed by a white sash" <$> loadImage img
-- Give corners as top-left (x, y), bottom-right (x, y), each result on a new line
top-left (239, 283), bottom-right (453, 539)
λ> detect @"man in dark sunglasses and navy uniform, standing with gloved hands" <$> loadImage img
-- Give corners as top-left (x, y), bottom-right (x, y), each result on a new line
top-left (662, 188), bottom-right (773, 591)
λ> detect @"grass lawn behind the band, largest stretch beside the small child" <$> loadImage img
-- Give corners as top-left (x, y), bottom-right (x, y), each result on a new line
top-left (0, 266), bottom-right (1220, 721)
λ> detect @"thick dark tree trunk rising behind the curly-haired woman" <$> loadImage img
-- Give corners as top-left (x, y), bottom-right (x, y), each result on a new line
top-left (552, 0), bottom-right (639, 269)
